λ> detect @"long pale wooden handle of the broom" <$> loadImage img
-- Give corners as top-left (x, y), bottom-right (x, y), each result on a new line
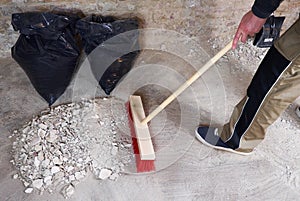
top-left (141, 41), bottom-right (232, 124)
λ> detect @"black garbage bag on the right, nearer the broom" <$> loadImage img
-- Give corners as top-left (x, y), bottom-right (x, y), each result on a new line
top-left (76, 15), bottom-right (140, 95)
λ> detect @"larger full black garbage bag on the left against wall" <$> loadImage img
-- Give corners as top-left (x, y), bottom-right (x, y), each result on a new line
top-left (11, 12), bottom-right (80, 105)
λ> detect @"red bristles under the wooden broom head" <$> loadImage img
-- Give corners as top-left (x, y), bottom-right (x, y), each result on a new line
top-left (125, 101), bottom-right (155, 172)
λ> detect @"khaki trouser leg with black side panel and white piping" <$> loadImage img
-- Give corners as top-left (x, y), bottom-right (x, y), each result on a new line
top-left (220, 19), bottom-right (300, 152)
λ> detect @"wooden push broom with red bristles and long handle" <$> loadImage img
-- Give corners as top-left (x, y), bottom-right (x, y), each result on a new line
top-left (126, 41), bottom-right (232, 172)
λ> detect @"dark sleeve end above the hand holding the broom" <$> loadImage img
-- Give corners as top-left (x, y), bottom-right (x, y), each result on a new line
top-left (252, 0), bottom-right (282, 18)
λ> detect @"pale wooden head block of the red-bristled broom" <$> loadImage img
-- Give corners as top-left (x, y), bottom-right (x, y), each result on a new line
top-left (129, 95), bottom-right (155, 160)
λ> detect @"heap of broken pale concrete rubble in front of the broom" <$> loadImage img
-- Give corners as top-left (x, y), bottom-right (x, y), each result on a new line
top-left (11, 98), bottom-right (134, 198)
